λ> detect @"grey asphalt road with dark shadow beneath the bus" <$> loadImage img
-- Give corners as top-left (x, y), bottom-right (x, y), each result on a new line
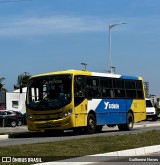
top-left (0, 120), bottom-right (160, 146)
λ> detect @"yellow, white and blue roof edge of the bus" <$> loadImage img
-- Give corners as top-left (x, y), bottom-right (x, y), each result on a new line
top-left (32, 69), bottom-right (142, 80)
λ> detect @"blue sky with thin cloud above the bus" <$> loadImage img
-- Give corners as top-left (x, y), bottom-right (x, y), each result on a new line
top-left (0, 0), bottom-right (160, 95)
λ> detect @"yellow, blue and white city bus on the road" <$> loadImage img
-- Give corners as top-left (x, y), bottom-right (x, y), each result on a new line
top-left (26, 70), bottom-right (146, 134)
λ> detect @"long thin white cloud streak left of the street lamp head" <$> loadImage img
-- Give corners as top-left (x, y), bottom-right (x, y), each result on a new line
top-left (0, 15), bottom-right (106, 36)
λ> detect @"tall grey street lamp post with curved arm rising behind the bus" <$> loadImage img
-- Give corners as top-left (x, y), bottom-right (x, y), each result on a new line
top-left (109, 22), bottom-right (127, 73)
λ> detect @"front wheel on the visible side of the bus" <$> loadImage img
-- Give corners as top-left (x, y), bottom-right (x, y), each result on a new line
top-left (87, 114), bottom-right (96, 134)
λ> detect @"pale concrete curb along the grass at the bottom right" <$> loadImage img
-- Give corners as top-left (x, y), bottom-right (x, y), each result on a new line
top-left (36, 145), bottom-right (160, 165)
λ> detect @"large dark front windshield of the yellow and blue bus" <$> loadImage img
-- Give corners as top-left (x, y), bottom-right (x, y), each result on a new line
top-left (26, 75), bottom-right (72, 110)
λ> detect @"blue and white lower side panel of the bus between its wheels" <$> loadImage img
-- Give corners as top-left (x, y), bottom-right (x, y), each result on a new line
top-left (89, 99), bottom-right (132, 125)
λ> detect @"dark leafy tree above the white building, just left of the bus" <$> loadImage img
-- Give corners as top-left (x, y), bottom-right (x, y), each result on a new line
top-left (14, 72), bottom-right (31, 90)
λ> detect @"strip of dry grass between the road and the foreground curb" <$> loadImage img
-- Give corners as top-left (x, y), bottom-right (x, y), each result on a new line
top-left (0, 130), bottom-right (160, 165)
